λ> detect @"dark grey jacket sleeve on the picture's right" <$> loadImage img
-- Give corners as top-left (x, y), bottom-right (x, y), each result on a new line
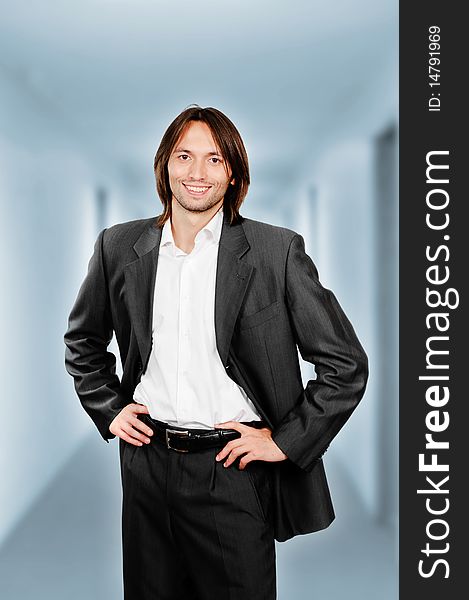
top-left (272, 234), bottom-right (368, 471)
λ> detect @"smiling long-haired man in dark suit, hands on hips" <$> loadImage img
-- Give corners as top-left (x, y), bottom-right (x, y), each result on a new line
top-left (65, 106), bottom-right (367, 600)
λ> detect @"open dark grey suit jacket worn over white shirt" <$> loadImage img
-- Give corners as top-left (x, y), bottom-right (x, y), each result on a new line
top-left (65, 216), bottom-right (368, 541)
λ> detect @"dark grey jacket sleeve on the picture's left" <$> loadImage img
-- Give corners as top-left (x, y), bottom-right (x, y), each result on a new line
top-left (64, 229), bottom-right (126, 442)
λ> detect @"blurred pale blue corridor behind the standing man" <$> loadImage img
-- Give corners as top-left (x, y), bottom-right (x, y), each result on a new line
top-left (0, 0), bottom-right (398, 600)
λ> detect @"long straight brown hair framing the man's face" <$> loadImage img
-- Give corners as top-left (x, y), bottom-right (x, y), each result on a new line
top-left (154, 104), bottom-right (250, 227)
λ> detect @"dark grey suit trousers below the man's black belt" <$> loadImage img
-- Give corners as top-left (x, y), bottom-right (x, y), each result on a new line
top-left (119, 417), bottom-right (276, 600)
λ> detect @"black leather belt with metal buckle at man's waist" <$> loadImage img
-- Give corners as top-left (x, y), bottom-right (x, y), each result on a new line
top-left (138, 413), bottom-right (266, 452)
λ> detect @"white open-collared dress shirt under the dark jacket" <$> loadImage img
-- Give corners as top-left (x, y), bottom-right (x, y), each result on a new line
top-left (133, 208), bottom-right (261, 429)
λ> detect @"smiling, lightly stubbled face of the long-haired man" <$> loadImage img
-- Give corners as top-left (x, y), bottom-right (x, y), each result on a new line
top-left (168, 121), bottom-right (231, 212)
